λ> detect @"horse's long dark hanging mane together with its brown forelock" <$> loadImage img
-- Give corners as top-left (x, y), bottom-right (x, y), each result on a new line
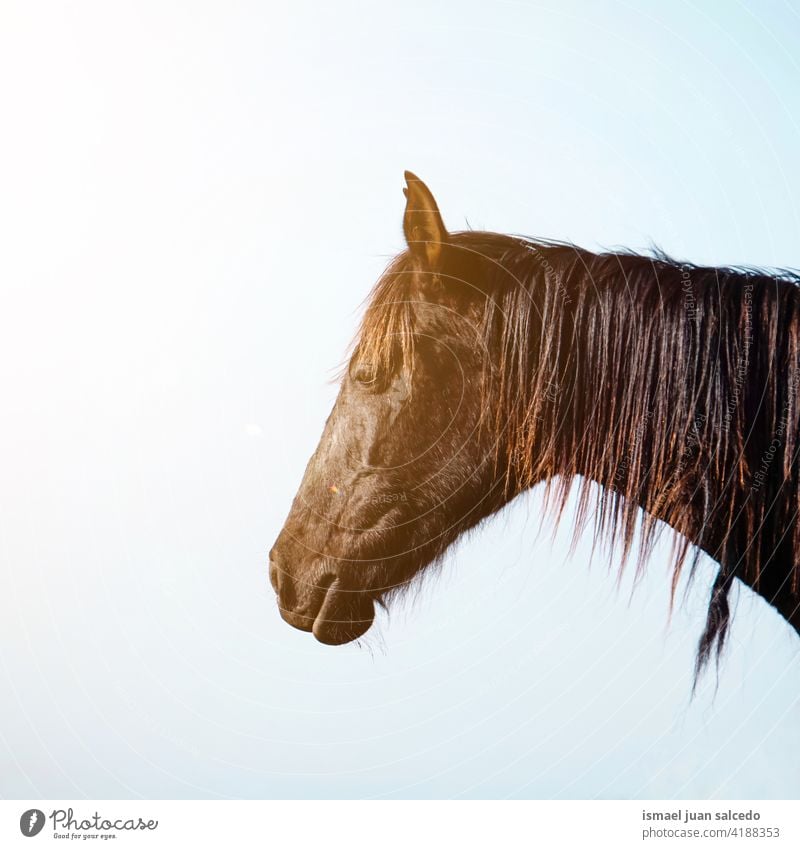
top-left (356, 231), bottom-right (800, 674)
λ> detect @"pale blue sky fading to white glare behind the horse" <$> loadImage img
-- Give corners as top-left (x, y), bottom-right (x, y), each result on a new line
top-left (0, 0), bottom-right (800, 799)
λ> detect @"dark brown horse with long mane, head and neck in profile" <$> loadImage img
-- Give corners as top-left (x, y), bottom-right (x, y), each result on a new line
top-left (269, 171), bottom-right (800, 675)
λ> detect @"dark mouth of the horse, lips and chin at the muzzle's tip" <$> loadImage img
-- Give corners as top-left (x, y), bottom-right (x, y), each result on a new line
top-left (278, 575), bottom-right (375, 646)
